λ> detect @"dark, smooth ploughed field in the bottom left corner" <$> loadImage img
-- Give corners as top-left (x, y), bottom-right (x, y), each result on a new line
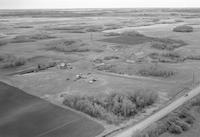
top-left (0, 82), bottom-right (104, 137)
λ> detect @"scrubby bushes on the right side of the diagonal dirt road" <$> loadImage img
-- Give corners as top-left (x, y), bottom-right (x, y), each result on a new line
top-left (132, 97), bottom-right (199, 137)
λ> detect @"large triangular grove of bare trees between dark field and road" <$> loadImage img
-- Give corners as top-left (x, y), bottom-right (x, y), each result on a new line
top-left (63, 91), bottom-right (157, 124)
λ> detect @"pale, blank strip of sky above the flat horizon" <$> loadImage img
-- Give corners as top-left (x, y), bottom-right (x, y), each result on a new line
top-left (0, 0), bottom-right (200, 9)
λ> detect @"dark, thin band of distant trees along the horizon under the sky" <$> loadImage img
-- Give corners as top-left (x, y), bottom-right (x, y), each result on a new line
top-left (0, 8), bottom-right (200, 18)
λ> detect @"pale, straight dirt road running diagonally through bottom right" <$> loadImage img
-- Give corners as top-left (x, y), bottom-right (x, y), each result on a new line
top-left (114, 86), bottom-right (200, 137)
